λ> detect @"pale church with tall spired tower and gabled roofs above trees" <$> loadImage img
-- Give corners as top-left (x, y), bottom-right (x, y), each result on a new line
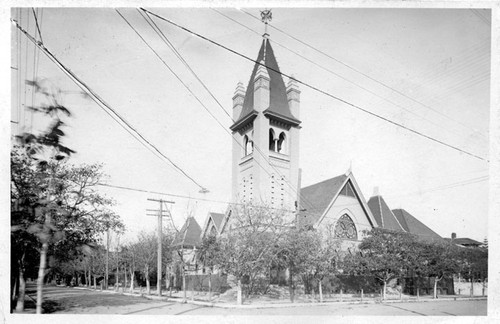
top-left (190, 12), bottom-right (441, 249)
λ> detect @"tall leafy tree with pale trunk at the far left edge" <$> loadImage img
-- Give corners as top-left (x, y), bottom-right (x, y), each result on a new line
top-left (11, 81), bottom-right (123, 313)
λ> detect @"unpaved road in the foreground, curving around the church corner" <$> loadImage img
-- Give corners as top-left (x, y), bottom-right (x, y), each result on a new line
top-left (14, 286), bottom-right (487, 316)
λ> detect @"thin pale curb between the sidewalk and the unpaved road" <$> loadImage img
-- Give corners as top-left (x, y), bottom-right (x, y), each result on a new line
top-left (68, 287), bottom-right (488, 309)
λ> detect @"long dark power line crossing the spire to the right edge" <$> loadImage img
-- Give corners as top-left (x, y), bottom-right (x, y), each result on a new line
top-left (141, 8), bottom-right (489, 162)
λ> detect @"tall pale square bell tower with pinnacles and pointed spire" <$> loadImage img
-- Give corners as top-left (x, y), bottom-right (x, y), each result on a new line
top-left (230, 10), bottom-right (301, 210)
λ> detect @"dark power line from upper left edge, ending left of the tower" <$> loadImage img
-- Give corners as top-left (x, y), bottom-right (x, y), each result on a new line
top-left (12, 20), bottom-right (207, 192)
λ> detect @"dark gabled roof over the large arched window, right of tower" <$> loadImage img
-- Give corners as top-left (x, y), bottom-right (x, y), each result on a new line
top-left (297, 172), bottom-right (376, 226)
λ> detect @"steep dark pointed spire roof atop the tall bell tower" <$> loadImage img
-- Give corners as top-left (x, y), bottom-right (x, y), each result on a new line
top-left (231, 39), bottom-right (300, 128)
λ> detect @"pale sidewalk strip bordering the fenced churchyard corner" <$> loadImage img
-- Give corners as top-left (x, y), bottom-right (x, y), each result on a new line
top-left (73, 287), bottom-right (487, 309)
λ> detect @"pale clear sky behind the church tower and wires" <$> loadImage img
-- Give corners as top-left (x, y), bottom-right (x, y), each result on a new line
top-left (7, 8), bottom-right (491, 246)
